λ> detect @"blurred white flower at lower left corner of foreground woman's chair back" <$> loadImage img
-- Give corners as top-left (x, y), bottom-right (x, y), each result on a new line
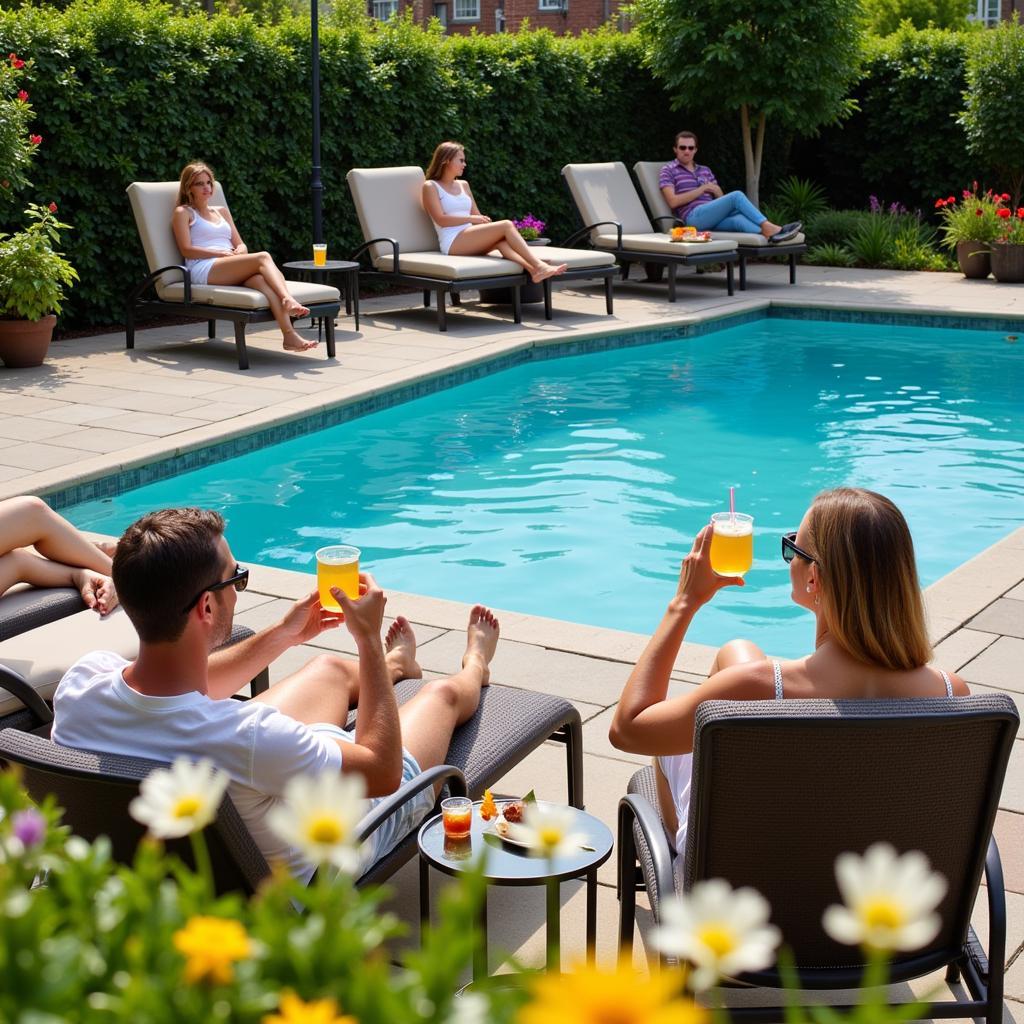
top-left (651, 879), bottom-right (782, 992)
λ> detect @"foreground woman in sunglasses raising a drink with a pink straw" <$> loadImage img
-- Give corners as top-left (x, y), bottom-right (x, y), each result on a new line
top-left (608, 487), bottom-right (970, 880)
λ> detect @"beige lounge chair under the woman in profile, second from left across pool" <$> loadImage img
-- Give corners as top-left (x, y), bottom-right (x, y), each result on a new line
top-left (346, 167), bottom-right (615, 331)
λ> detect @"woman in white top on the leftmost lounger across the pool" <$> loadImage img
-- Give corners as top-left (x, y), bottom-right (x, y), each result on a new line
top-left (171, 163), bottom-right (316, 352)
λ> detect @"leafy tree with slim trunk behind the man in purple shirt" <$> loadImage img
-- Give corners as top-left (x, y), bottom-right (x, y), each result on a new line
top-left (633, 0), bottom-right (863, 204)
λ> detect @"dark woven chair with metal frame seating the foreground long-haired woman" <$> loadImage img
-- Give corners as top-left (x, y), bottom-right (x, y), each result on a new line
top-left (618, 694), bottom-right (1019, 1024)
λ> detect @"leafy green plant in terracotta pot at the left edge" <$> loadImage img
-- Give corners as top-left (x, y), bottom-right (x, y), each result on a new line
top-left (0, 203), bottom-right (78, 368)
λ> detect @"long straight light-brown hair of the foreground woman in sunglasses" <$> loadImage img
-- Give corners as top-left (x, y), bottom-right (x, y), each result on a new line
top-left (807, 487), bottom-right (932, 671)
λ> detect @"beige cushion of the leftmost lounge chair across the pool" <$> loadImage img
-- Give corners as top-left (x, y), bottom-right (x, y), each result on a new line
top-left (127, 181), bottom-right (341, 309)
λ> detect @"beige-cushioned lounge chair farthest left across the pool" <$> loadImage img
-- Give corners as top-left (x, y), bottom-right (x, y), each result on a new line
top-left (125, 181), bottom-right (341, 370)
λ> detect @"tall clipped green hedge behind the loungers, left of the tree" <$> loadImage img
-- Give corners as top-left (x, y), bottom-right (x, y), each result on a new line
top-left (0, 0), bottom-right (679, 325)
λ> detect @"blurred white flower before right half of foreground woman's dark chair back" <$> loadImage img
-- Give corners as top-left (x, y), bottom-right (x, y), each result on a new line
top-left (822, 843), bottom-right (947, 952)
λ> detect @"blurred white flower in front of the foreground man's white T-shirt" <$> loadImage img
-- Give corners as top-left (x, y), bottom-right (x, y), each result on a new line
top-left (267, 772), bottom-right (369, 874)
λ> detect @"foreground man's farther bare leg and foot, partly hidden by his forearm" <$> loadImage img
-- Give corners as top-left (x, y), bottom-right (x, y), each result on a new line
top-left (253, 615), bottom-right (423, 725)
